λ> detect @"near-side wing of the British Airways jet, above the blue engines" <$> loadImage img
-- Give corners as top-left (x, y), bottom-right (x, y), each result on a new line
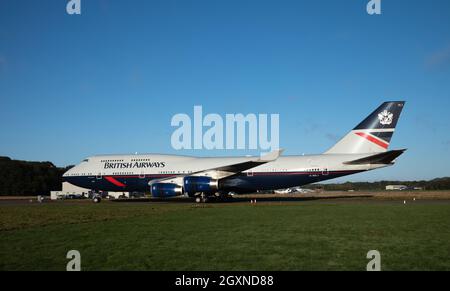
top-left (149, 149), bottom-right (284, 185)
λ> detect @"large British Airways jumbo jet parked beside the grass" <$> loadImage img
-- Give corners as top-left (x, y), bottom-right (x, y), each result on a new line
top-left (63, 101), bottom-right (406, 203)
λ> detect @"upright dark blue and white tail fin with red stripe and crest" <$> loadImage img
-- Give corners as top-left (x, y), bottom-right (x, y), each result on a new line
top-left (325, 101), bottom-right (405, 154)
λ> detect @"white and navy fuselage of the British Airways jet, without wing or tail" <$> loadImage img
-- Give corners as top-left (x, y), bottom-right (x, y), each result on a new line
top-left (64, 154), bottom-right (386, 193)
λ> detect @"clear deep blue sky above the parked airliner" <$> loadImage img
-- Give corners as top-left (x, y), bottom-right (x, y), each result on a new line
top-left (0, 0), bottom-right (450, 181)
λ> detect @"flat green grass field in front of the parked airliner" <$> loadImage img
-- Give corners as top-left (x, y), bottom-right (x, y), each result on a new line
top-left (0, 201), bottom-right (450, 270)
